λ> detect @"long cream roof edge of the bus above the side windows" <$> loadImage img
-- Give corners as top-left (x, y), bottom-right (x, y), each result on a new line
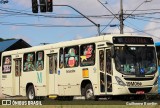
top-left (3, 34), bottom-right (154, 54)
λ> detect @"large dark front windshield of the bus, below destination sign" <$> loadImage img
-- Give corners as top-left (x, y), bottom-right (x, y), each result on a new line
top-left (115, 45), bottom-right (157, 76)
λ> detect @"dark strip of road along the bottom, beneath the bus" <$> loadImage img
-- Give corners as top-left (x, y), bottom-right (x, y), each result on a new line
top-left (0, 98), bottom-right (160, 105)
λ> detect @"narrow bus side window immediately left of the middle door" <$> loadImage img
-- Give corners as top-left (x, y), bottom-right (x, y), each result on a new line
top-left (36, 51), bottom-right (44, 71)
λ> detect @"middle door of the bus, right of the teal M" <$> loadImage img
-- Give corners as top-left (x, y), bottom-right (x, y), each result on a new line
top-left (48, 53), bottom-right (58, 95)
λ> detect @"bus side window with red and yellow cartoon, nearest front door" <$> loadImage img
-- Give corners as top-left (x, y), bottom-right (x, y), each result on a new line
top-left (80, 44), bottom-right (95, 66)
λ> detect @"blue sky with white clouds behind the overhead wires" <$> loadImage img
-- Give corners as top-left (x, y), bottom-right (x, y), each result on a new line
top-left (0, 0), bottom-right (160, 46)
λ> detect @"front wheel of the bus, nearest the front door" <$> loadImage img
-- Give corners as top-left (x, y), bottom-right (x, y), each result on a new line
top-left (85, 84), bottom-right (95, 100)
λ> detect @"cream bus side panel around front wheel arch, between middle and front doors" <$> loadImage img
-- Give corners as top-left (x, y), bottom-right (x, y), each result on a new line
top-left (58, 66), bottom-right (99, 96)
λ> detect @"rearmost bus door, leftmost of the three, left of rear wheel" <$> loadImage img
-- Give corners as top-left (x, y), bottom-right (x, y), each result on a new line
top-left (14, 58), bottom-right (22, 95)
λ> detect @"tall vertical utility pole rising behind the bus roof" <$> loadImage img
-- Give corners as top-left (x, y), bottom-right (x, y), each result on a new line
top-left (119, 0), bottom-right (124, 34)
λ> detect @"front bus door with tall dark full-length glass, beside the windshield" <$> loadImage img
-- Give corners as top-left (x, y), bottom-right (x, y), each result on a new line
top-left (99, 48), bottom-right (112, 94)
